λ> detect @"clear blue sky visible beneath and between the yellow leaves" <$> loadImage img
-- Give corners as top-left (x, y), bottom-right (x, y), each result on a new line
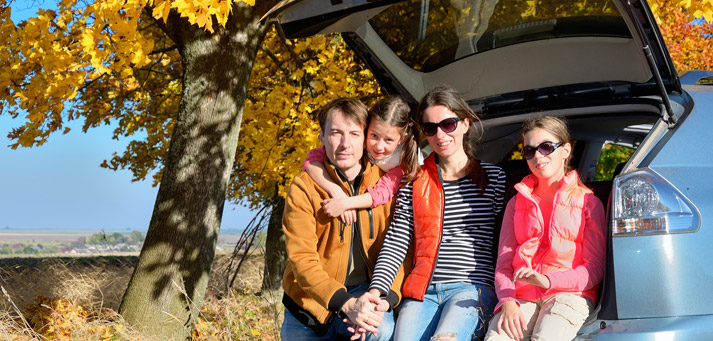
top-left (0, 1), bottom-right (253, 231)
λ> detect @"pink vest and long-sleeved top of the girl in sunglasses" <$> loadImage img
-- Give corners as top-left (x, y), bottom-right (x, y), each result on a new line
top-left (495, 171), bottom-right (606, 312)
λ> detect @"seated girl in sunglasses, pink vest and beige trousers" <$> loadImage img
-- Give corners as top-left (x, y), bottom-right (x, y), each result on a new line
top-left (486, 116), bottom-right (605, 340)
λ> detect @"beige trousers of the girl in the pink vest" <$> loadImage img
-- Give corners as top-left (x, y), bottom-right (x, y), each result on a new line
top-left (485, 293), bottom-right (594, 341)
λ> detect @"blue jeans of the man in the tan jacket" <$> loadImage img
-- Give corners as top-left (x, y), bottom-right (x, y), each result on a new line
top-left (280, 282), bottom-right (394, 341)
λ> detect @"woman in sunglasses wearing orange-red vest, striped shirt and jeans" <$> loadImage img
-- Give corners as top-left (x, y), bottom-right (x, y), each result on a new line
top-left (362, 86), bottom-right (505, 340)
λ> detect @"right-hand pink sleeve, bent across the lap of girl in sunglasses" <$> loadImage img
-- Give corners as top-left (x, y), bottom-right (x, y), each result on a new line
top-left (544, 194), bottom-right (606, 291)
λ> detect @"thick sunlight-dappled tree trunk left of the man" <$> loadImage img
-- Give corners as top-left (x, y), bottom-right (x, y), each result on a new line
top-left (119, 1), bottom-right (274, 340)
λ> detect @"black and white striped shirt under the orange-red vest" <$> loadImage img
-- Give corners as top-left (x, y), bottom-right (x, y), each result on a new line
top-left (370, 162), bottom-right (505, 292)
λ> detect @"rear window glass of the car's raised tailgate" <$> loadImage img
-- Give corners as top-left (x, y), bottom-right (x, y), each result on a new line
top-left (369, 0), bottom-right (631, 72)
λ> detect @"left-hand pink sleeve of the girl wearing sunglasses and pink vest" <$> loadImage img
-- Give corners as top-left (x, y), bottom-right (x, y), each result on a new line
top-left (493, 196), bottom-right (520, 313)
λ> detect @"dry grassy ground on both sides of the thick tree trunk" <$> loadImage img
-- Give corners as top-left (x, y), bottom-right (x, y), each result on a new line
top-left (0, 254), bottom-right (283, 341)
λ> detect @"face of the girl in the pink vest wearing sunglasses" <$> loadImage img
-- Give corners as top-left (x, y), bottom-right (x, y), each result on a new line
top-left (522, 128), bottom-right (572, 181)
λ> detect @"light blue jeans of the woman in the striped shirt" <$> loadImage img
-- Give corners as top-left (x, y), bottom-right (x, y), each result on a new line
top-left (394, 282), bottom-right (497, 341)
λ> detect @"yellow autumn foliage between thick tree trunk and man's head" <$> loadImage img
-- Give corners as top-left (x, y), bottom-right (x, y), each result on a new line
top-left (229, 30), bottom-right (379, 207)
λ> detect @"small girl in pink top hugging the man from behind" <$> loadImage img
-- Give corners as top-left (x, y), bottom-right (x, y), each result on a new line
top-left (303, 96), bottom-right (420, 224)
